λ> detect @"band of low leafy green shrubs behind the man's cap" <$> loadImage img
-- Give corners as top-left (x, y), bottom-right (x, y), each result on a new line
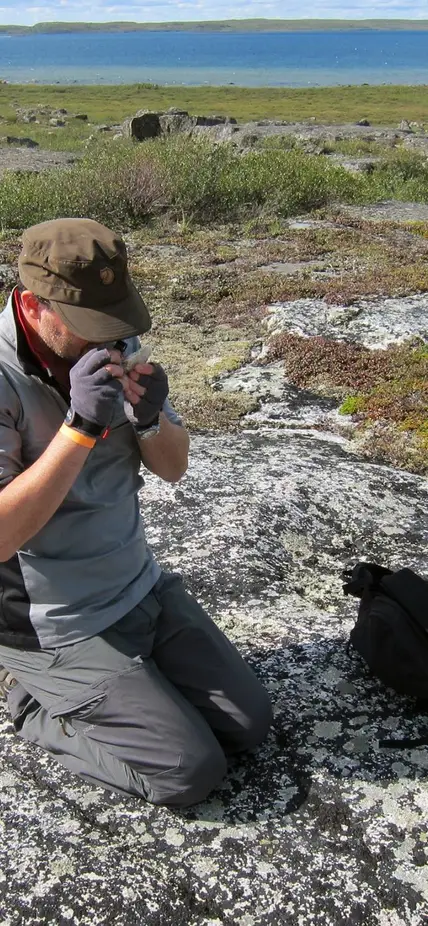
top-left (0, 136), bottom-right (428, 234)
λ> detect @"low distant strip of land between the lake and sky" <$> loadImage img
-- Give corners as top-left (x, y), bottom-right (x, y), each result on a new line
top-left (0, 19), bottom-right (428, 36)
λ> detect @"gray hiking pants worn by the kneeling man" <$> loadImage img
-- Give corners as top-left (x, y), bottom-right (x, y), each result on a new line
top-left (0, 573), bottom-right (272, 806)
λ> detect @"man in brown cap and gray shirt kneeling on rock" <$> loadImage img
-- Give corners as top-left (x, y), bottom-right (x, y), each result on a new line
top-left (0, 219), bottom-right (271, 806)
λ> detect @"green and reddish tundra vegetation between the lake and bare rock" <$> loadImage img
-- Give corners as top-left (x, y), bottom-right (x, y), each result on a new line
top-left (0, 85), bottom-right (428, 472)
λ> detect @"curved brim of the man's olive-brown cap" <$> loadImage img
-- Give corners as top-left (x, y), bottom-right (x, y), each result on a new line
top-left (49, 280), bottom-right (152, 344)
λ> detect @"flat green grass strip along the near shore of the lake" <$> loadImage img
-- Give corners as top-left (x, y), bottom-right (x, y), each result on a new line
top-left (0, 84), bottom-right (428, 134)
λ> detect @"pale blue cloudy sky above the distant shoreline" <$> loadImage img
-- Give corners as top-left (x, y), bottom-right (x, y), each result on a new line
top-left (0, 0), bottom-right (428, 25)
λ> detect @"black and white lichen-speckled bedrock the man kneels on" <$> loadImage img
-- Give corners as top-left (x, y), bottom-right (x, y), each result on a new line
top-left (0, 286), bottom-right (428, 926)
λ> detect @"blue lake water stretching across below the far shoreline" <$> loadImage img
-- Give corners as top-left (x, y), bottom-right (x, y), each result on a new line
top-left (0, 30), bottom-right (428, 87)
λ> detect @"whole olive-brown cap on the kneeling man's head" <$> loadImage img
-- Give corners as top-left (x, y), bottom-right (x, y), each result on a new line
top-left (18, 219), bottom-right (151, 343)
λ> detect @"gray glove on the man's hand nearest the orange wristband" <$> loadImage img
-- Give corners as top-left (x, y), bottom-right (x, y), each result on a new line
top-left (70, 347), bottom-right (122, 431)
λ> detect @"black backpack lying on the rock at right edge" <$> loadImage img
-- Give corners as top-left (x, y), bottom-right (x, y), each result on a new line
top-left (342, 563), bottom-right (428, 746)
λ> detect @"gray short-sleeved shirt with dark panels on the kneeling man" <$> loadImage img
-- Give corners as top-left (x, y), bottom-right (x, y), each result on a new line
top-left (0, 297), bottom-right (181, 648)
